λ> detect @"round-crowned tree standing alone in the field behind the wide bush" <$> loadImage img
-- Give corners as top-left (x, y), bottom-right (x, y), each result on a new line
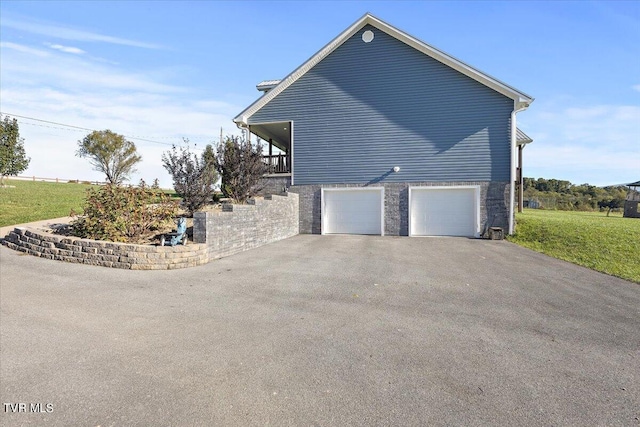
top-left (76, 129), bottom-right (142, 185)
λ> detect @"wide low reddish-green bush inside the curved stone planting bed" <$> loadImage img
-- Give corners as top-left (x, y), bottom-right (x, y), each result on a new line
top-left (71, 181), bottom-right (178, 243)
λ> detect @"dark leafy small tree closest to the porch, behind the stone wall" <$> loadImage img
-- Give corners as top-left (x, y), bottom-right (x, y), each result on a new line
top-left (215, 136), bottom-right (267, 203)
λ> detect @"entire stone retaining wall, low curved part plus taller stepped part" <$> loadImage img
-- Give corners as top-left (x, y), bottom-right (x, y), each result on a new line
top-left (2, 193), bottom-right (298, 270)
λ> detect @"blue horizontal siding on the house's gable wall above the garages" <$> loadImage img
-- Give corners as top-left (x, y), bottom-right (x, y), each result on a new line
top-left (249, 26), bottom-right (513, 185)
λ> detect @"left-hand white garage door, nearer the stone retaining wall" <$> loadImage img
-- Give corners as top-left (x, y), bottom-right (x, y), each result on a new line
top-left (322, 188), bottom-right (384, 235)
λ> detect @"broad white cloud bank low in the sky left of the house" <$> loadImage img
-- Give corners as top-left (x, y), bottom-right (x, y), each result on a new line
top-left (0, 36), bottom-right (243, 187)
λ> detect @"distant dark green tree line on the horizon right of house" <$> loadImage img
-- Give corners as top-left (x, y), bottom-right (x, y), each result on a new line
top-left (523, 178), bottom-right (628, 212)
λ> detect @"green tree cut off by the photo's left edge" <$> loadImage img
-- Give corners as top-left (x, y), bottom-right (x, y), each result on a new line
top-left (0, 116), bottom-right (31, 185)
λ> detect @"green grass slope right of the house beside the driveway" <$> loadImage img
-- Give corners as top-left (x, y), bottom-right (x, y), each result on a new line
top-left (509, 209), bottom-right (640, 283)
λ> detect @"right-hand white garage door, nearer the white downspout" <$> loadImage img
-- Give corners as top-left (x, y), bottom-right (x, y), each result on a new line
top-left (409, 187), bottom-right (480, 237)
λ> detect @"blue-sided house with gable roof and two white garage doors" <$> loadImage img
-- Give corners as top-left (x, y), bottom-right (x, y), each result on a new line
top-left (234, 14), bottom-right (533, 237)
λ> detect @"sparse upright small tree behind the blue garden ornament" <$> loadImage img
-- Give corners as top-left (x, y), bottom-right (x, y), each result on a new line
top-left (162, 140), bottom-right (218, 215)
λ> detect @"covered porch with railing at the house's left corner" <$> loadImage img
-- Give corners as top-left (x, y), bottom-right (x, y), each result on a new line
top-left (248, 122), bottom-right (292, 175)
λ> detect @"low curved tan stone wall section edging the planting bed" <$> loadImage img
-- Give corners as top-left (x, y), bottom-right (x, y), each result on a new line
top-left (2, 228), bottom-right (209, 270)
